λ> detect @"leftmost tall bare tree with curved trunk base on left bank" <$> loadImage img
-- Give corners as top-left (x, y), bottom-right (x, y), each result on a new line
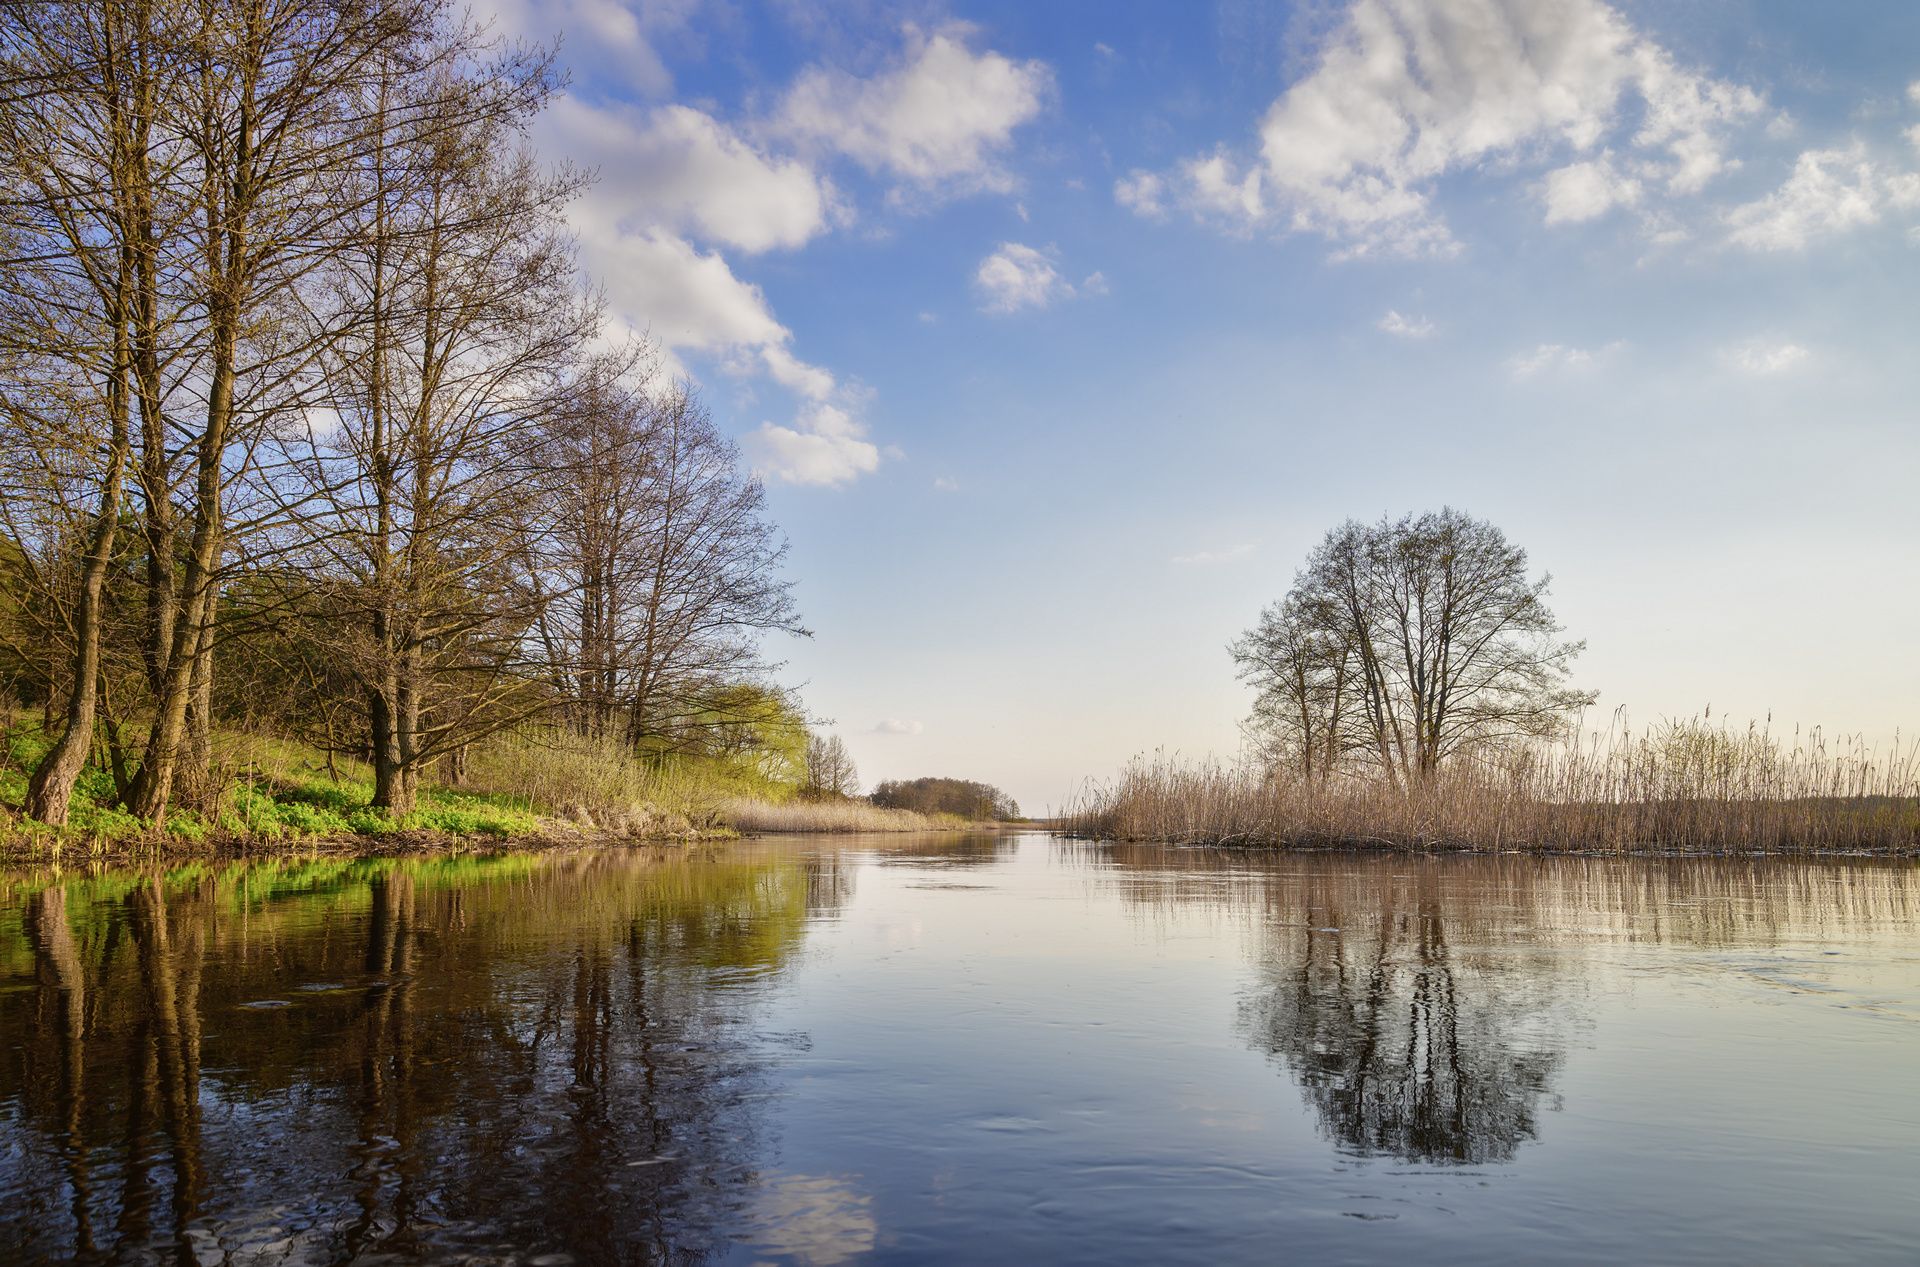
top-left (0, 0), bottom-right (173, 824)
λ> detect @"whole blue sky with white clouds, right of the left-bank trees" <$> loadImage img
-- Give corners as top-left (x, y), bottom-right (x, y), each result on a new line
top-left (482, 0), bottom-right (1920, 812)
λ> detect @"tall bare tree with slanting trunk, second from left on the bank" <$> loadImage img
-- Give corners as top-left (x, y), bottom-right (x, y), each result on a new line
top-left (131, 0), bottom-right (445, 820)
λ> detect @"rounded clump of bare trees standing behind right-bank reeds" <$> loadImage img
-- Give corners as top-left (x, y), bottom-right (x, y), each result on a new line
top-left (1231, 509), bottom-right (1594, 783)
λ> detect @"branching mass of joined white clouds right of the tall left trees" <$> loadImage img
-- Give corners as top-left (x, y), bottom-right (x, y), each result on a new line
top-left (499, 20), bottom-right (1071, 486)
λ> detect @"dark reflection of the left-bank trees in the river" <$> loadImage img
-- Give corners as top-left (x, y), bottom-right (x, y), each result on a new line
top-left (0, 849), bottom-right (851, 1261)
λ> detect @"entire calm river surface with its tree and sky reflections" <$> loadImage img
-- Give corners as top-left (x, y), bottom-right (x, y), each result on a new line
top-left (0, 837), bottom-right (1920, 1263)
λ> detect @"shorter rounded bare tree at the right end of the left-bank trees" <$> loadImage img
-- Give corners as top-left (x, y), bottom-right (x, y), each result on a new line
top-left (534, 370), bottom-right (806, 753)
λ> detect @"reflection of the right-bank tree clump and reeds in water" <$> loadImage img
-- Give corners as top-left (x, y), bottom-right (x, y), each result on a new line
top-left (1108, 847), bottom-right (1920, 1165)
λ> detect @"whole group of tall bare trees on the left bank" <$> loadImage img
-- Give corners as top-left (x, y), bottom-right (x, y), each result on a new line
top-left (0, 0), bottom-right (799, 824)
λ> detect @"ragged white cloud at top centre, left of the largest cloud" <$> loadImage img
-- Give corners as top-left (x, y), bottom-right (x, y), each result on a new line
top-left (772, 23), bottom-right (1052, 192)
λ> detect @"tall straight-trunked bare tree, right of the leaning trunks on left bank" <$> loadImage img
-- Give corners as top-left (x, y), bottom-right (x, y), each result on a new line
top-left (280, 29), bottom-right (597, 814)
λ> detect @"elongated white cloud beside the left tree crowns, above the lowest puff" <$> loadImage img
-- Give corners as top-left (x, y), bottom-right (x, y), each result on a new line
top-left (541, 96), bottom-right (837, 253)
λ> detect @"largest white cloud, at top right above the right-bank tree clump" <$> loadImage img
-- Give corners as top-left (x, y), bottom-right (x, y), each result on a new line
top-left (1116, 0), bottom-right (1764, 255)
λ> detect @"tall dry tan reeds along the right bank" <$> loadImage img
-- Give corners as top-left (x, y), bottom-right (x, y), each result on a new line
top-left (1064, 720), bottom-right (1920, 854)
